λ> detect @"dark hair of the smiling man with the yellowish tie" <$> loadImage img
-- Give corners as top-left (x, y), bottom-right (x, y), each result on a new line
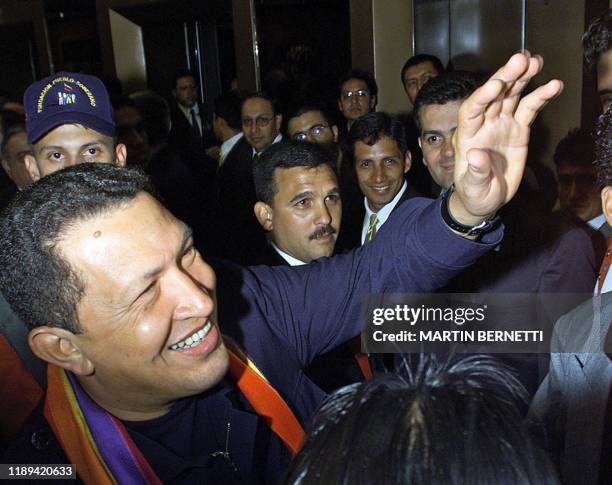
top-left (346, 111), bottom-right (408, 160)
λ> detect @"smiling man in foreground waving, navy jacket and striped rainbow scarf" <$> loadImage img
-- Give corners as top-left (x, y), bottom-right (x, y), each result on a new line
top-left (0, 54), bottom-right (562, 484)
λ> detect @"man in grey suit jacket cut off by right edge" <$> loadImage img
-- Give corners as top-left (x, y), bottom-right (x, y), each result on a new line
top-left (531, 95), bottom-right (612, 484)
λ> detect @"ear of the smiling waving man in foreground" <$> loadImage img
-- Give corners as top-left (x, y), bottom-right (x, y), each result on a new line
top-left (28, 326), bottom-right (94, 376)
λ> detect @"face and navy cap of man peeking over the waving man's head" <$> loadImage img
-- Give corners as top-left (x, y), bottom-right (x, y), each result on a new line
top-left (23, 72), bottom-right (126, 181)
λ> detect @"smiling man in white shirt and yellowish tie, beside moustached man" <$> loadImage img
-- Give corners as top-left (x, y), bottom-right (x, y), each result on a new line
top-left (338, 112), bottom-right (418, 249)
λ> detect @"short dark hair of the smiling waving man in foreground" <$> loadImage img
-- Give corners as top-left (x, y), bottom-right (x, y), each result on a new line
top-left (0, 163), bottom-right (152, 333)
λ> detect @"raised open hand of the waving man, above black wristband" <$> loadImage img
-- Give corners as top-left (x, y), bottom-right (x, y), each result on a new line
top-left (449, 52), bottom-right (563, 226)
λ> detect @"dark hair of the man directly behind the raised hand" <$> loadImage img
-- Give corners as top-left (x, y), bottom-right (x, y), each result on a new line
top-left (412, 71), bottom-right (478, 134)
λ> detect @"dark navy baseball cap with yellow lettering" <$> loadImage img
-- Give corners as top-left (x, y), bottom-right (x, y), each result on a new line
top-left (23, 72), bottom-right (115, 144)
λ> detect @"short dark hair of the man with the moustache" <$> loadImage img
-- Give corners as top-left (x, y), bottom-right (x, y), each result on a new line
top-left (253, 140), bottom-right (338, 204)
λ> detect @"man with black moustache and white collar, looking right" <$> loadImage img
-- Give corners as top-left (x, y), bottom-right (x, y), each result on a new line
top-left (253, 140), bottom-right (342, 266)
